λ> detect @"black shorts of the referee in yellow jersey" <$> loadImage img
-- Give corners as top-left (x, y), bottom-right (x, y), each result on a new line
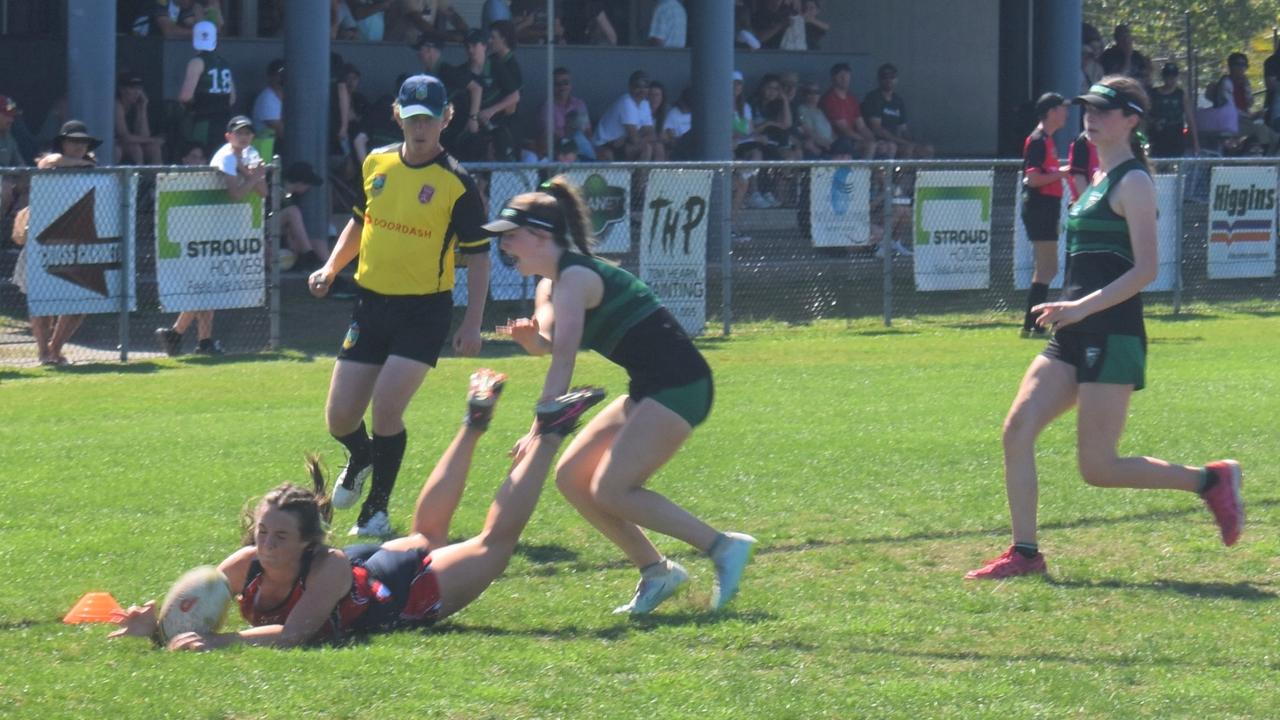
top-left (338, 288), bottom-right (453, 368)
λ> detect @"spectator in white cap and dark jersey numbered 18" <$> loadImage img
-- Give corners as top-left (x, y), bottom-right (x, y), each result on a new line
top-left (178, 20), bottom-right (236, 152)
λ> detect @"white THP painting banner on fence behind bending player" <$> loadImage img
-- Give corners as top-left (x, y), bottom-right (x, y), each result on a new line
top-left (640, 170), bottom-right (712, 336)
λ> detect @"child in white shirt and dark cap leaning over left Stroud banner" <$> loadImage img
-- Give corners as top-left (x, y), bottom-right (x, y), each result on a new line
top-left (155, 115), bottom-right (268, 357)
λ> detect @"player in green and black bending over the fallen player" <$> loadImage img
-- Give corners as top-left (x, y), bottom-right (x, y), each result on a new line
top-left (484, 176), bottom-right (755, 615)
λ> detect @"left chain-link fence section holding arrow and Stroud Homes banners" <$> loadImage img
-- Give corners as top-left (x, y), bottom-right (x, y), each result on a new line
top-left (0, 167), bottom-right (279, 365)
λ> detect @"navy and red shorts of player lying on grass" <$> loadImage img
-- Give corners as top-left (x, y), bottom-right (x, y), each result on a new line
top-left (342, 544), bottom-right (440, 632)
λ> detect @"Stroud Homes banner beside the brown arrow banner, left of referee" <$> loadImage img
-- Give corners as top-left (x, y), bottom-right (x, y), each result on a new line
top-left (156, 173), bottom-right (266, 313)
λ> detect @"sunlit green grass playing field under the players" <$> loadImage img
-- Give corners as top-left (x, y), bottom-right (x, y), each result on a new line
top-left (0, 304), bottom-right (1280, 719)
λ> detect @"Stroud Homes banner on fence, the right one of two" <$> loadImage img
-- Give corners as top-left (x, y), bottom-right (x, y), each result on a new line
top-left (914, 170), bottom-right (992, 291)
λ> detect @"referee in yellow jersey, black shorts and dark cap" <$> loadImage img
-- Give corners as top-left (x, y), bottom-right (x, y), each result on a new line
top-left (308, 74), bottom-right (489, 536)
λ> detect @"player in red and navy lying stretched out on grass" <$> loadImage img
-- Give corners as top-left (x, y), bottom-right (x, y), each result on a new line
top-left (110, 370), bottom-right (604, 650)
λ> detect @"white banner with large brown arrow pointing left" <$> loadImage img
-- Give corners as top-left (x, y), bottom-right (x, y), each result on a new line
top-left (24, 170), bottom-right (137, 316)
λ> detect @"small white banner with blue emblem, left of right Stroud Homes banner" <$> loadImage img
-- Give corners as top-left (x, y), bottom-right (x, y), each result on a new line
top-left (809, 168), bottom-right (872, 247)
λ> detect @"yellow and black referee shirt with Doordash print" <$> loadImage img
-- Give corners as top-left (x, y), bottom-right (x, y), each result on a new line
top-left (352, 142), bottom-right (489, 295)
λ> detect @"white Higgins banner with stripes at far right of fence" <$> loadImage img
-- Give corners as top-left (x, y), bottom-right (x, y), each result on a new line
top-left (1208, 167), bottom-right (1276, 279)
